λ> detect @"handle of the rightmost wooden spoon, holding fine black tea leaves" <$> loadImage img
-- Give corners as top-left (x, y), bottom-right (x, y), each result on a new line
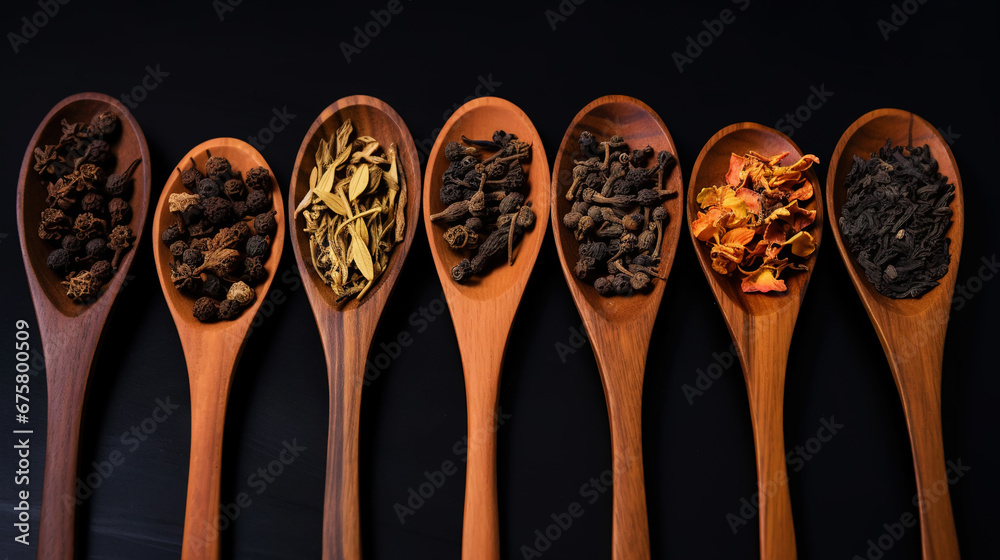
top-left (887, 321), bottom-right (962, 560)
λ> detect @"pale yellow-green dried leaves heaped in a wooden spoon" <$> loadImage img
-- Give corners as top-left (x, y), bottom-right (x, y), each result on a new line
top-left (295, 119), bottom-right (406, 302)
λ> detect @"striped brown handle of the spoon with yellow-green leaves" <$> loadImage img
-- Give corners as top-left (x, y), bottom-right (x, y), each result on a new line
top-left (321, 313), bottom-right (375, 560)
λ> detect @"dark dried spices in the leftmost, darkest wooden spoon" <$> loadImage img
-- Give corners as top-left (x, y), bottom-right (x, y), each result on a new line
top-left (34, 111), bottom-right (142, 303)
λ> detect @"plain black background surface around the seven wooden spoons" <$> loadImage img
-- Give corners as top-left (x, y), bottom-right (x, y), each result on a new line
top-left (0, 0), bottom-right (1000, 559)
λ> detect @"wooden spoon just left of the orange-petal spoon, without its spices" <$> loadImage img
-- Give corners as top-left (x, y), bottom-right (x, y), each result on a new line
top-left (551, 95), bottom-right (684, 560)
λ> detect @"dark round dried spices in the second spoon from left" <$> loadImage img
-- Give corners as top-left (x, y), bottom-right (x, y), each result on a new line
top-left (160, 152), bottom-right (278, 323)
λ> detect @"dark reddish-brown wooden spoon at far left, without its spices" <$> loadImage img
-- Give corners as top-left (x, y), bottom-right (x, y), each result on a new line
top-left (17, 93), bottom-right (151, 560)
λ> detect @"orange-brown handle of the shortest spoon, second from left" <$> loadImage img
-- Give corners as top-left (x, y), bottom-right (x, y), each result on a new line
top-left (181, 337), bottom-right (239, 560)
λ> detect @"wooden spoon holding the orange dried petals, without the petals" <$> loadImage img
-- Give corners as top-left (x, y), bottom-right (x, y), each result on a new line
top-left (687, 123), bottom-right (823, 560)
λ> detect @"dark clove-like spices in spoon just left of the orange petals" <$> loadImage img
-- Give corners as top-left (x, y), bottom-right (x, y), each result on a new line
top-left (562, 132), bottom-right (677, 296)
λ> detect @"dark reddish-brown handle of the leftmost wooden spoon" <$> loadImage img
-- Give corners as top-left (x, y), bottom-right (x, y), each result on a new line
top-left (36, 329), bottom-right (98, 560)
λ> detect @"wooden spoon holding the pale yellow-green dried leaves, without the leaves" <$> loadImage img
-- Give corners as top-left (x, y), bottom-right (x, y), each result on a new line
top-left (288, 95), bottom-right (420, 560)
